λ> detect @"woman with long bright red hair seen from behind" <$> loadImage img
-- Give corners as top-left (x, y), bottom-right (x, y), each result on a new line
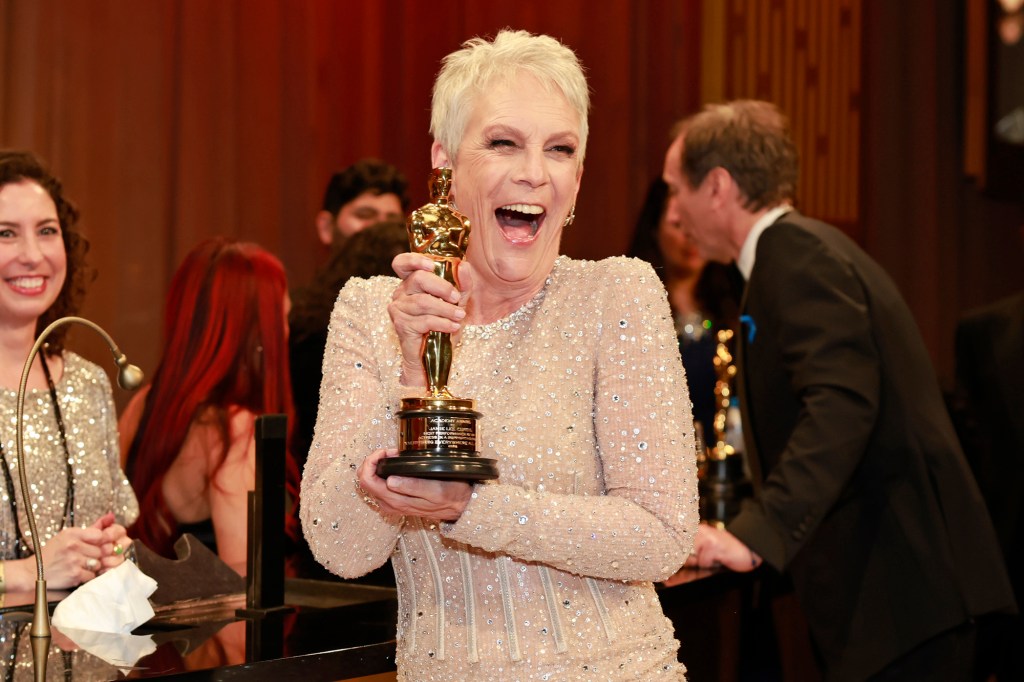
top-left (120, 238), bottom-right (298, 574)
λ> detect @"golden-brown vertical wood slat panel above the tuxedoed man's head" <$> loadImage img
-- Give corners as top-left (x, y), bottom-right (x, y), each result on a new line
top-left (722, 0), bottom-right (862, 231)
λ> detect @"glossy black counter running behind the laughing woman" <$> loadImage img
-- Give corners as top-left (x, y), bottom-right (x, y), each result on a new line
top-left (0, 569), bottom-right (798, 682)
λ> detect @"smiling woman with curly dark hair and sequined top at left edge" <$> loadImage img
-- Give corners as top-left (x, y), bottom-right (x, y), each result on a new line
top-left (0, 152), bottom-right (138, 592)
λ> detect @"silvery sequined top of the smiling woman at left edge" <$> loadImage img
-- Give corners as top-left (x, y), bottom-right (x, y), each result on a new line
top-left (0, 351), bottom-right (138, 559)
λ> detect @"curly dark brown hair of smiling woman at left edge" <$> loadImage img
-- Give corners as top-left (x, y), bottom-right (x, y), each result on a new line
top-left (0, 150), bottom-right (95, 355)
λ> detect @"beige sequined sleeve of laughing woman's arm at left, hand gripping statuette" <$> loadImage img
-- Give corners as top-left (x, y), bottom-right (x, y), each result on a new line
top-left (301, 278), bottom-right (401, 578)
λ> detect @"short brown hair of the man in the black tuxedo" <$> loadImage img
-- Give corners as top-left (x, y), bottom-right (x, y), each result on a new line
top-left (680, 99), bottom-right (799, 211)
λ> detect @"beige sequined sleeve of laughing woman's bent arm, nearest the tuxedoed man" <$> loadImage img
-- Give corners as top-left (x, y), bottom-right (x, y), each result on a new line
top-left (441, 258), bottom-right (698, 581)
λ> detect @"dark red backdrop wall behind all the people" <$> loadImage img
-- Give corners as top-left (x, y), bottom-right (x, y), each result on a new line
top-left (0, 0), bottom-right (1024, 399)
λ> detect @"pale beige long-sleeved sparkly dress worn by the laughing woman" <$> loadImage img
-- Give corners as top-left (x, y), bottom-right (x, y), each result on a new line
top-left (302, 257), bottom-right (697, 681)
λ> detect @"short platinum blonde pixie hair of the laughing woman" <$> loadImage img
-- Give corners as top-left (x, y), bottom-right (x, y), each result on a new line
top-left (430, 29), bottom-right (590, 165)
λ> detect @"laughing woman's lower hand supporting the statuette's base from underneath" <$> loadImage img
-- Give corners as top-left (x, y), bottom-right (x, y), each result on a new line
top-left (356, 449), bottom-right (473, 521)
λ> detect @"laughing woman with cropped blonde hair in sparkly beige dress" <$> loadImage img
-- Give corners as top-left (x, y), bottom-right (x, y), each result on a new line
top-left (302, 31), bottom-right (697, 681)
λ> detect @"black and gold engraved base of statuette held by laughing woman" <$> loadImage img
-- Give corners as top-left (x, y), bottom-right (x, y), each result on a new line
top-left (377, 397), bottom-right (498, 481)
